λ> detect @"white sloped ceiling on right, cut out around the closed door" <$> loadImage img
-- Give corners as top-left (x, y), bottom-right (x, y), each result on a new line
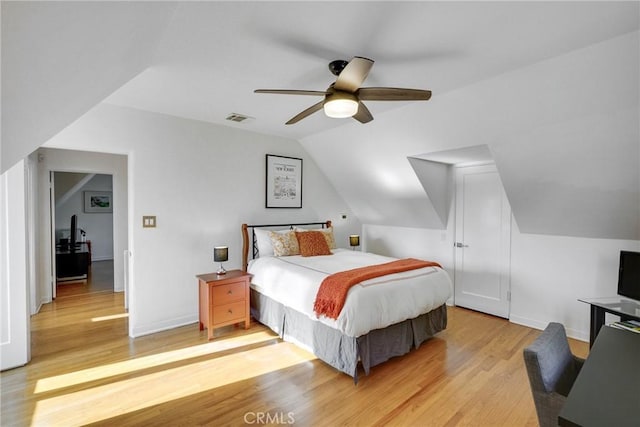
top-left (302, 32), bottom-right (640, 240)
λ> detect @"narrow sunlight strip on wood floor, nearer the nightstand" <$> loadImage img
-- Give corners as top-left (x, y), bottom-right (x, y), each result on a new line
top-left (34, 332), bottom-right (277, 394)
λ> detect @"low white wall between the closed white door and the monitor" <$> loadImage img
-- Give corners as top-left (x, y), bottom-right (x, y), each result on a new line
top-left (510, 222), bottom-right (640, 341)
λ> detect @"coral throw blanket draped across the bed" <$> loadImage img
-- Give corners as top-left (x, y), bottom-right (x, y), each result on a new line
top-left (313, 258), bottom-right (442, 319)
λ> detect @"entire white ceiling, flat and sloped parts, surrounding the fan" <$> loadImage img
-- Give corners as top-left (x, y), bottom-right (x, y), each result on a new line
top-left (1, 1), bottom-right (640, 239)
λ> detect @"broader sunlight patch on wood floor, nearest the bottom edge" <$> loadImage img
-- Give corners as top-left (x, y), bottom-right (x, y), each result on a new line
top-left (32, 342), bottom-right (315, 426)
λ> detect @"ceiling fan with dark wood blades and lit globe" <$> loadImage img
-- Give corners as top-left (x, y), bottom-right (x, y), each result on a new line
top-left (254, 56), bottom-right (431, 125)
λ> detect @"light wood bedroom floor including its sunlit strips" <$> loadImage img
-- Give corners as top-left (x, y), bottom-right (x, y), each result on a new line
top-left (0, 284), bottom-right (588, 426)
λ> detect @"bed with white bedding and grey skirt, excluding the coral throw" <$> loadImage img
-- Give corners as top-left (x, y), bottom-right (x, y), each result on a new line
top-left (242, 221), bottom-right (452, 383)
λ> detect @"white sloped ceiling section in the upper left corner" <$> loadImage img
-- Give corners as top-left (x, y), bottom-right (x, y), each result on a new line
top-left (0, 1), bottom-right (175, 172)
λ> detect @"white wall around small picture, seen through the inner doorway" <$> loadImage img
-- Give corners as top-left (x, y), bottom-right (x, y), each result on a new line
top-left (56, 174), bottom-right (115, 261)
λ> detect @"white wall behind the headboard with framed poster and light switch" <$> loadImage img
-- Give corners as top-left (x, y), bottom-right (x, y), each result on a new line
top-left (47, 104), bottom-right (361, 336)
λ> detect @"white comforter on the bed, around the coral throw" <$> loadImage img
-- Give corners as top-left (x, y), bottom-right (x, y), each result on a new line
top-left (248, 249), bottom-right (452, 337)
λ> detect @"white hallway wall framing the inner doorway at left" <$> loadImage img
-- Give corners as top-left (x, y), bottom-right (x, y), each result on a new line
top-left (36, 148), bottom-right (128, 313)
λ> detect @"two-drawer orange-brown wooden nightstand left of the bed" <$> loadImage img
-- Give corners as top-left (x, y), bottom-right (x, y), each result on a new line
top-left (196, 270), bottom-right (251, 339)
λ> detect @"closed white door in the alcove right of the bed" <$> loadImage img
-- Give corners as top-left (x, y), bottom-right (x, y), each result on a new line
top-left (454, 165), bottom-right (511, 318)
